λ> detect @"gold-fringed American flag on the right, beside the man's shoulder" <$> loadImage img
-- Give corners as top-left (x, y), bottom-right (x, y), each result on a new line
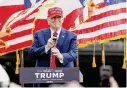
top-left (73, 0), bottom-right (127, 47)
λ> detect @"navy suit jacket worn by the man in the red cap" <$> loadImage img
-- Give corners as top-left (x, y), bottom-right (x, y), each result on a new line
top-left (29, 28), bottom-right (77, 67)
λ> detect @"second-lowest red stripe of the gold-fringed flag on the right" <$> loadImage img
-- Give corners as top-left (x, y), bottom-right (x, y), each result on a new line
top-left (73, 19), bottom-right (127, 34)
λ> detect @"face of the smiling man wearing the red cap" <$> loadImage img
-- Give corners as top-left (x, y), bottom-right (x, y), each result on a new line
top-left (47, 16), bottom-right (63, 30)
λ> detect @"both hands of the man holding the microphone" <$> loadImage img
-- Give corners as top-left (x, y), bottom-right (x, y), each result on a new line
top-left (47, 37), bottom-right (63, 60)
